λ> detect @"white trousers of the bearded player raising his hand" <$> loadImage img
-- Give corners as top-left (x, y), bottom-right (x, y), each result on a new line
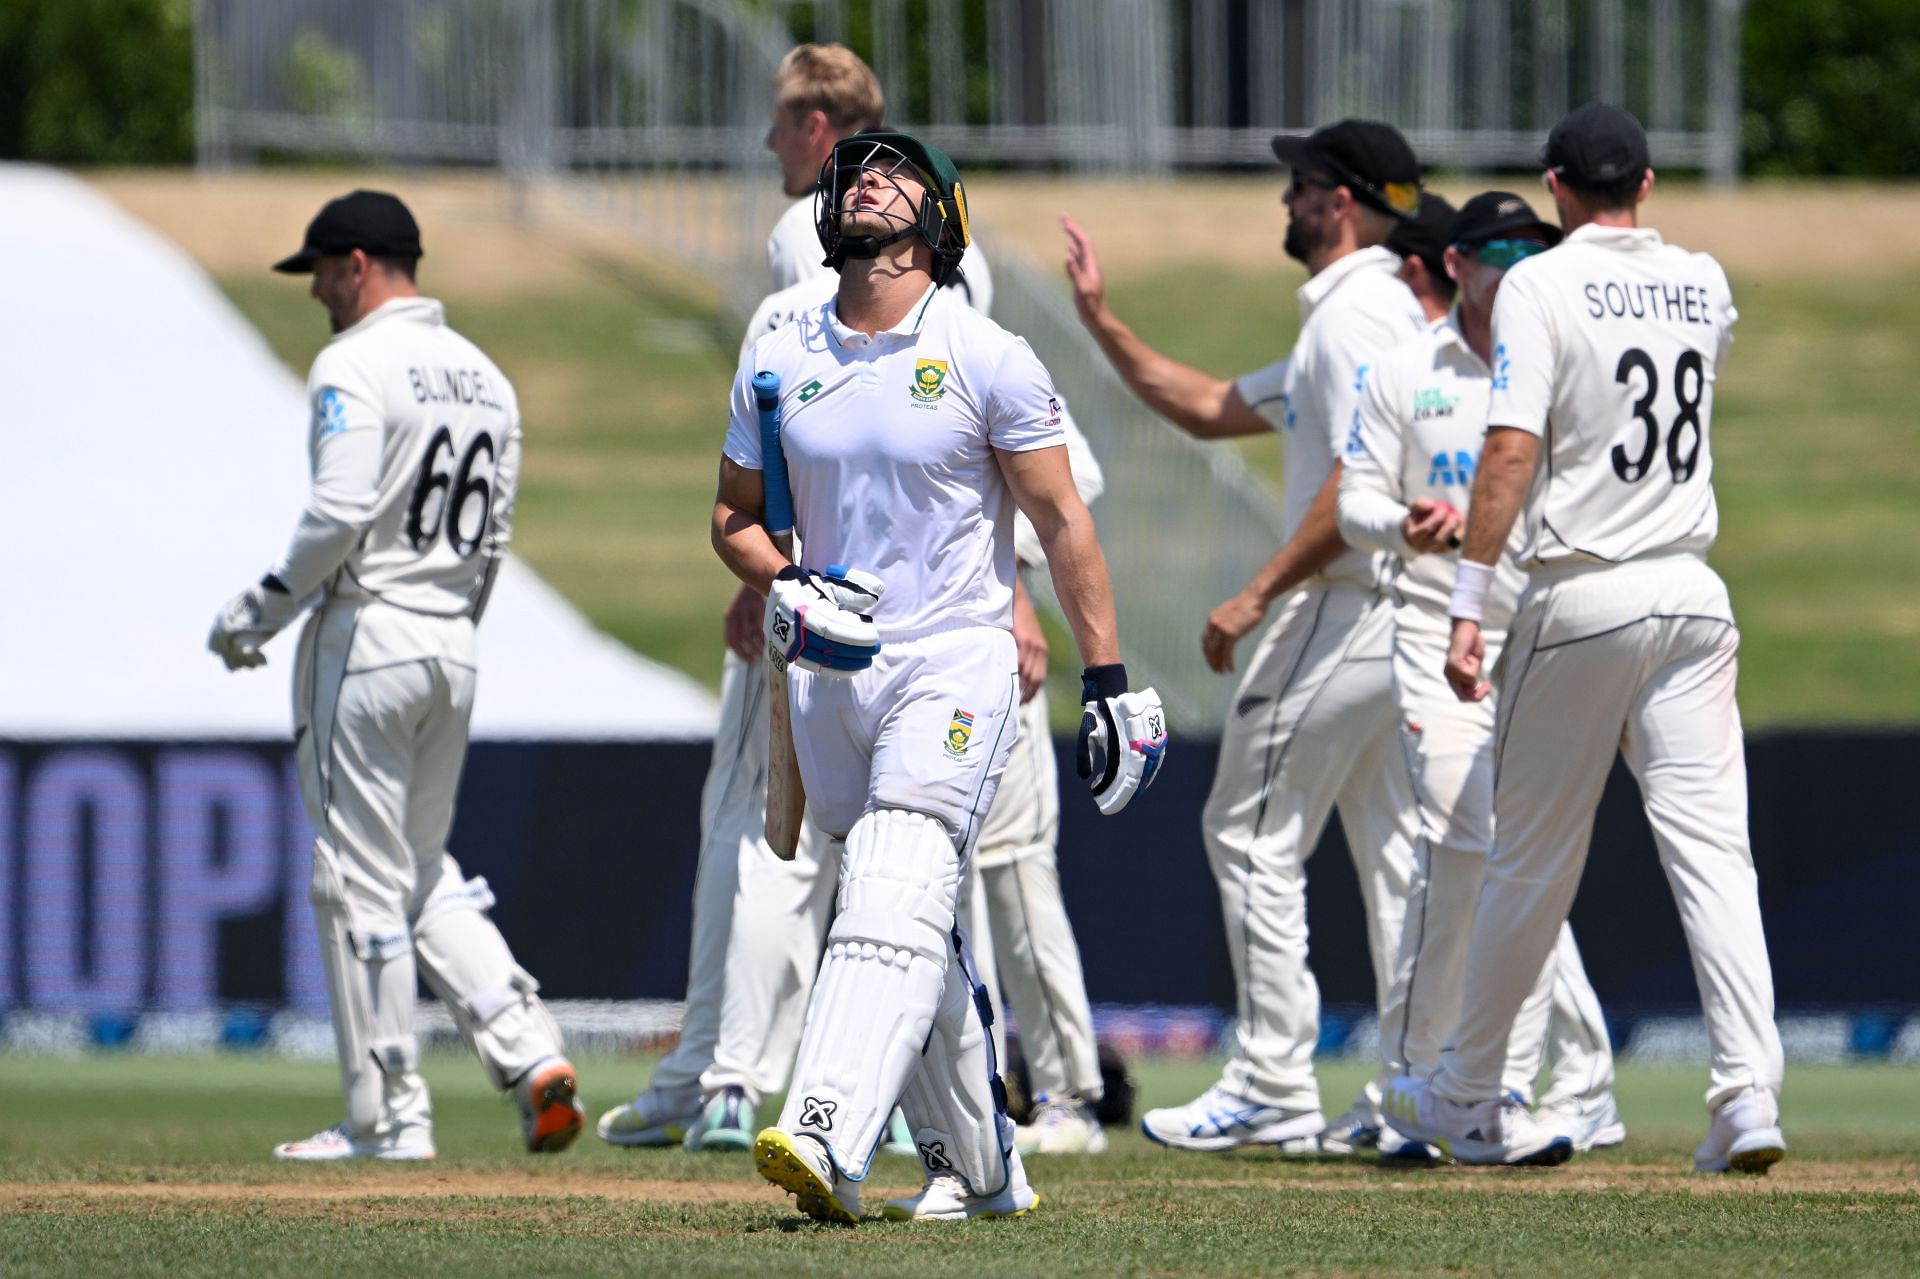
top-left (1202, 586), bottom-right (1420, 1112)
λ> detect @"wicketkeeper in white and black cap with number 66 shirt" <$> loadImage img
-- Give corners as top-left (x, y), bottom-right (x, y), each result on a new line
top-left (207, 190), bottom-right (584, 1160)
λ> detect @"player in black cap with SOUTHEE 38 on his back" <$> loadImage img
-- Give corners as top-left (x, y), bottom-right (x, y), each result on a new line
top-left (1386, 102), bottom-right (1786, 1171)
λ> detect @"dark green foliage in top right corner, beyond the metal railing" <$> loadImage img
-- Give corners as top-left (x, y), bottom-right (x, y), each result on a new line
top-left (1741, 0), bottom-right (1920, 177)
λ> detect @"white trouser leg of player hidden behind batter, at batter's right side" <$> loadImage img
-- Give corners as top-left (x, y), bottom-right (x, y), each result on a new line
top-left (970, 688), bottom-right (1106, 1100)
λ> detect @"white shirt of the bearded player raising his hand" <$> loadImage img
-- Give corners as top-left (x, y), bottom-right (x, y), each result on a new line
top-left (1235, 246), bottom-right (1427, 590)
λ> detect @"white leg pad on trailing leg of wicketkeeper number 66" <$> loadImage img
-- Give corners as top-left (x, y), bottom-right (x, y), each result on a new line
top-left (413, 878), bottom-right (563, 1089)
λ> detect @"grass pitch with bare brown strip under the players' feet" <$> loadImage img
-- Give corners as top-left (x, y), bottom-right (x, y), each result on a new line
top-left (0, 1056), bottom-right (1920, 1279)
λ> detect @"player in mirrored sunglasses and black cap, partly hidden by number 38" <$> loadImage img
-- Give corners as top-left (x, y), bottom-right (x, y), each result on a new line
top-left (1338, 192), bottom-right (1626, 1154)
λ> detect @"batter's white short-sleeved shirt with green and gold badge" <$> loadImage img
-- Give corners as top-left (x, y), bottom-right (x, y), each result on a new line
top-left (726, 286), bottom-right (1066, 641)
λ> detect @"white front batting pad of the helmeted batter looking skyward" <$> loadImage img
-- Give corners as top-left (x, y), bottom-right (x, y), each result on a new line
top-left (780, 808), bottom-right (960, 1181)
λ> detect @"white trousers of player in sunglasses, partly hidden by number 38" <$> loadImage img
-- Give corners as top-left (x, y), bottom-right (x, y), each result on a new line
top-left (1380, 618), bottom-right (1613, 1102)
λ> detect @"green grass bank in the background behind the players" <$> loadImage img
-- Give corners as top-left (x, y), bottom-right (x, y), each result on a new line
top-left (210, 242), bottom-right (1920, 726)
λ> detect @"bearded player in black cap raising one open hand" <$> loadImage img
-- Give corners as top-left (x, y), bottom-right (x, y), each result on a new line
top-left (1068, 121), bottom-right (1436, 1154)
